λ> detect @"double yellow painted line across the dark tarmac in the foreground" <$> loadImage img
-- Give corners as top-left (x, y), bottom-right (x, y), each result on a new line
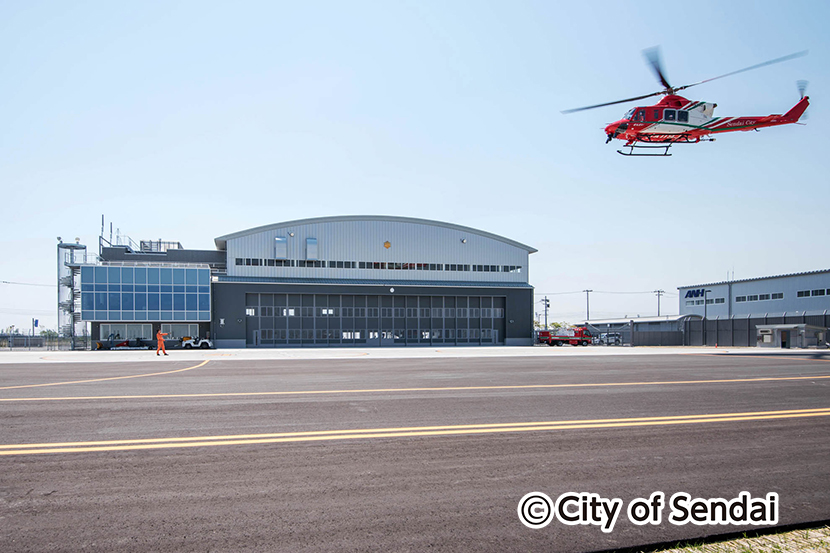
top-left (0, 408), bottom-right (830, 456)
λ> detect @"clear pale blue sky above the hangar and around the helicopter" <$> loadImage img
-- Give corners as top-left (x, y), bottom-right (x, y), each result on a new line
top-left (0, 1), bottom-right (830, 328)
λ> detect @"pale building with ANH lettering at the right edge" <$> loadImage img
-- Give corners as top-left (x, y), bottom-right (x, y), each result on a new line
top-left (678, 269), bottom-right (830, 348)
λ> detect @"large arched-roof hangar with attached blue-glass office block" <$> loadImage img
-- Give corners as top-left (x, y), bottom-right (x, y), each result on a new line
top-left (73, 216), bottom-right (536, 347)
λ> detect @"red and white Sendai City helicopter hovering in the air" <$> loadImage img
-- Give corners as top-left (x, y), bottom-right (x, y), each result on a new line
top-left (562, 47), bottom-right (810, 157)
